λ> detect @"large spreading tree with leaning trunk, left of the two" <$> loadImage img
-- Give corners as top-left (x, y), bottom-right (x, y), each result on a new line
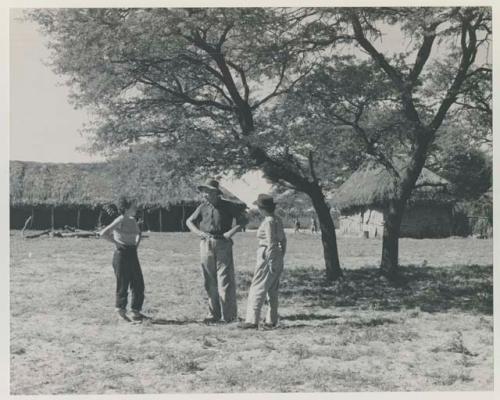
top-left (29, 8), bottom-right (348, 280)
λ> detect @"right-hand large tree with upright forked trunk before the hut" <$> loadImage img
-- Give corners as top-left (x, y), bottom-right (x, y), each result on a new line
top-left (296, 7), bottom-right (491, 277)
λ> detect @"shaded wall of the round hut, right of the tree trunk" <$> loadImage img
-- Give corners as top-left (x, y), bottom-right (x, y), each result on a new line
top-left (401, 205), bottom-right (453, 238)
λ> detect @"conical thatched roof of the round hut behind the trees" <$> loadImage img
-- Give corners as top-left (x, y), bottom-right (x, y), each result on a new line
top-left (331, 161), bottom-right (453, 214)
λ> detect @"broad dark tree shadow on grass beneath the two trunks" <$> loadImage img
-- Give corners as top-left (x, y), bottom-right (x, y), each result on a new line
top-left (238, 265), bottom-right (493, 320)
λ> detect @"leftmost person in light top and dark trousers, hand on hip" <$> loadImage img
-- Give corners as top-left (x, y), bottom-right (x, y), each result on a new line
top-left (99, 196), bottom-right (147, 322)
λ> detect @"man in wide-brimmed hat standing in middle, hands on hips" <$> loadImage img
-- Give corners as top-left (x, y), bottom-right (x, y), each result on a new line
top-left (186, 179), bottom-right (248, 322)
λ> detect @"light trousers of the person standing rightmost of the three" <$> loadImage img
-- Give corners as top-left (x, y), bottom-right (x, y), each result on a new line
top-left (246, 246), bottom-right (283, 325)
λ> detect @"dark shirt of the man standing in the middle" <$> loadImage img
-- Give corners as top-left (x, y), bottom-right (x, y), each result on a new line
top-left (190, 199), bottom-right (248, 235)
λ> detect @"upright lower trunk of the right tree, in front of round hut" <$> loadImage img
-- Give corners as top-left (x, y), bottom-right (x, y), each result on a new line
top-left (380, 201), bottom-right (404, 278)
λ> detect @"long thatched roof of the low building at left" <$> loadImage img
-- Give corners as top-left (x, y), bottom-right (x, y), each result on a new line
top-left (10, 161), bottom-right (244, 208)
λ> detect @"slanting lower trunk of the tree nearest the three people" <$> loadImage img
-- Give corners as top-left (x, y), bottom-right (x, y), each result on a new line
top-left (307, 186), bottom-right (344, 282)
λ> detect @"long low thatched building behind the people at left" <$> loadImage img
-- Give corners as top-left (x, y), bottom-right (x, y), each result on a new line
top-left (10, 161), bottom-right (245, 232)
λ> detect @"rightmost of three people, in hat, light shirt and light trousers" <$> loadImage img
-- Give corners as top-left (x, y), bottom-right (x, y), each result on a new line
top-left (240, 194), bottom-right (286, 329)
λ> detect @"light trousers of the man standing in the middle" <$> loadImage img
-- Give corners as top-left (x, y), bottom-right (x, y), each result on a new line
top-left (200, 239), bottom-right (237, 322)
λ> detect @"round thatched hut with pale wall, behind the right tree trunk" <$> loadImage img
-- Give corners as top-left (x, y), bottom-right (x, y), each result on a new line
top-left (332, 162), bottom-right (454, 238)
